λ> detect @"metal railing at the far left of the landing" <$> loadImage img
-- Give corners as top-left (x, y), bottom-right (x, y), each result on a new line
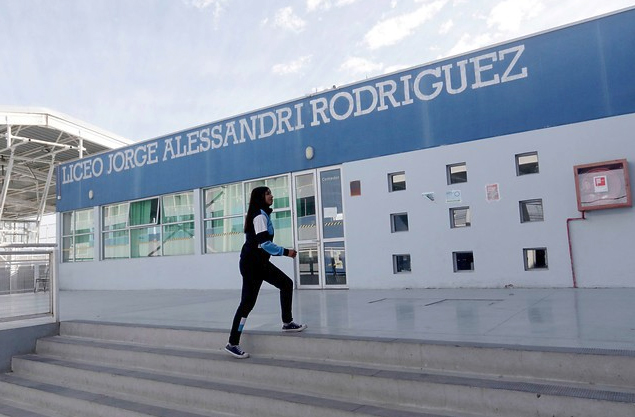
top-left (0, 243), bottom-right (58, 324)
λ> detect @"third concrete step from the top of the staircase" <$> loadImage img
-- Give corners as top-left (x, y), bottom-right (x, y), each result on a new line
top-left (7, 355), bottom-right (460, 417)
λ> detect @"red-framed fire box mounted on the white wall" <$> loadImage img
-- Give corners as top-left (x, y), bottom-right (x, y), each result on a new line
top-left (573, 159), bottom-right (632, 211)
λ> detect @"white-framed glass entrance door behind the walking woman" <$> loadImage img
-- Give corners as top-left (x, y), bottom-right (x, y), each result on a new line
top-left (293, 168), bottom-right (347, 288)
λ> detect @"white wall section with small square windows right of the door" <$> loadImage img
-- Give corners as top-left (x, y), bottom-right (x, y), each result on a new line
top-left (343, 115), bottom-right (635, 288)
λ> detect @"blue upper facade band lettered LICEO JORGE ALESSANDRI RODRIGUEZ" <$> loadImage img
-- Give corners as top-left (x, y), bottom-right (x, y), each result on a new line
top-left (57, 9), bottom-right (635, 212)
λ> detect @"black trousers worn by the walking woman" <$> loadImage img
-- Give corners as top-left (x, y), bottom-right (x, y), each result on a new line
top-left (229, 258), bottom-right (293, 345)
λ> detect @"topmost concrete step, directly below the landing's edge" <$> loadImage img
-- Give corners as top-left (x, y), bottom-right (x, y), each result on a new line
top-left (60, 321), bottom-right (635, 388)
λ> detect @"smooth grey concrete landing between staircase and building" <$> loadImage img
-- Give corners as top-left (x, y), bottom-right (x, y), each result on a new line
top-left (60, 284), bottom-right (635, 350)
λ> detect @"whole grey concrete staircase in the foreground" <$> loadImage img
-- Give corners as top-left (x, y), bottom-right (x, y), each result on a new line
top-left (0, 321), bottom-right (635, 417)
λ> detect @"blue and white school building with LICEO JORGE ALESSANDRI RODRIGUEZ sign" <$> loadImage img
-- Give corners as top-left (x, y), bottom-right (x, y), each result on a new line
top-left (56, 8), bottom-right (635, 290)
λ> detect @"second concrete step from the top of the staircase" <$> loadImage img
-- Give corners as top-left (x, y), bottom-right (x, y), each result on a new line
top-left (31, 336), bottom-right (635, 415)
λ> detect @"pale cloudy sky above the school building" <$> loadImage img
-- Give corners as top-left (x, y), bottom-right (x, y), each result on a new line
top-left (0, 0), bottom-right (635, 141)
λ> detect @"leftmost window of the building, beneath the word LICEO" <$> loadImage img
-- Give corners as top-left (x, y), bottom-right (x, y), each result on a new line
top-left (62, 208), bottom-right (95, 262)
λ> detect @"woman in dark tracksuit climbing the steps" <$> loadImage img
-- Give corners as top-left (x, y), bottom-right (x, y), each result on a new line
top-left (225, 187), bottom-right (306, 359)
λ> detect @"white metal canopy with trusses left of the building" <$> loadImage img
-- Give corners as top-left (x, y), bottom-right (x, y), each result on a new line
top-left (0, 106), bottom-right (133, 228)
